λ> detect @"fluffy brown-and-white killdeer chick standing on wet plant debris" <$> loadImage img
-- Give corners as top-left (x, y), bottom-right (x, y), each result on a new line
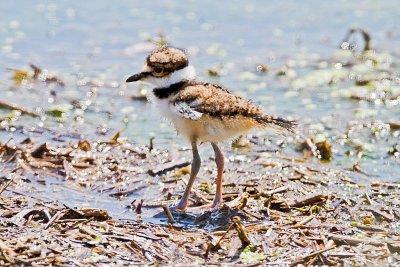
top-left (126, 45), bottom-right (296, 211)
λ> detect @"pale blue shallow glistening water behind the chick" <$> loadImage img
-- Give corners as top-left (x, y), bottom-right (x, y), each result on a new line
top-left (0, 1), bottom-right (400, 221)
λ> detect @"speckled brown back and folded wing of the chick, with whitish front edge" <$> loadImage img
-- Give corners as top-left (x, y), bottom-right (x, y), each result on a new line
top-left (171, 83), bottom-right (262, 120)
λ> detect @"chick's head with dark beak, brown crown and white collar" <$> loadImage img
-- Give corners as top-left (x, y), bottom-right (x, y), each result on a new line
top-left (126, 46), bottom-right (196, 88)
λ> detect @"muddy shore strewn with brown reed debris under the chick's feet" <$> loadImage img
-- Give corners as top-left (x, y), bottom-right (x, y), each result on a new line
top-left (0, 130), bottom-right (400, 266)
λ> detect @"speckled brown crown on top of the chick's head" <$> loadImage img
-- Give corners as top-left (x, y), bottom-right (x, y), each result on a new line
top-left (147, 46), bottom-right (189, 72)
